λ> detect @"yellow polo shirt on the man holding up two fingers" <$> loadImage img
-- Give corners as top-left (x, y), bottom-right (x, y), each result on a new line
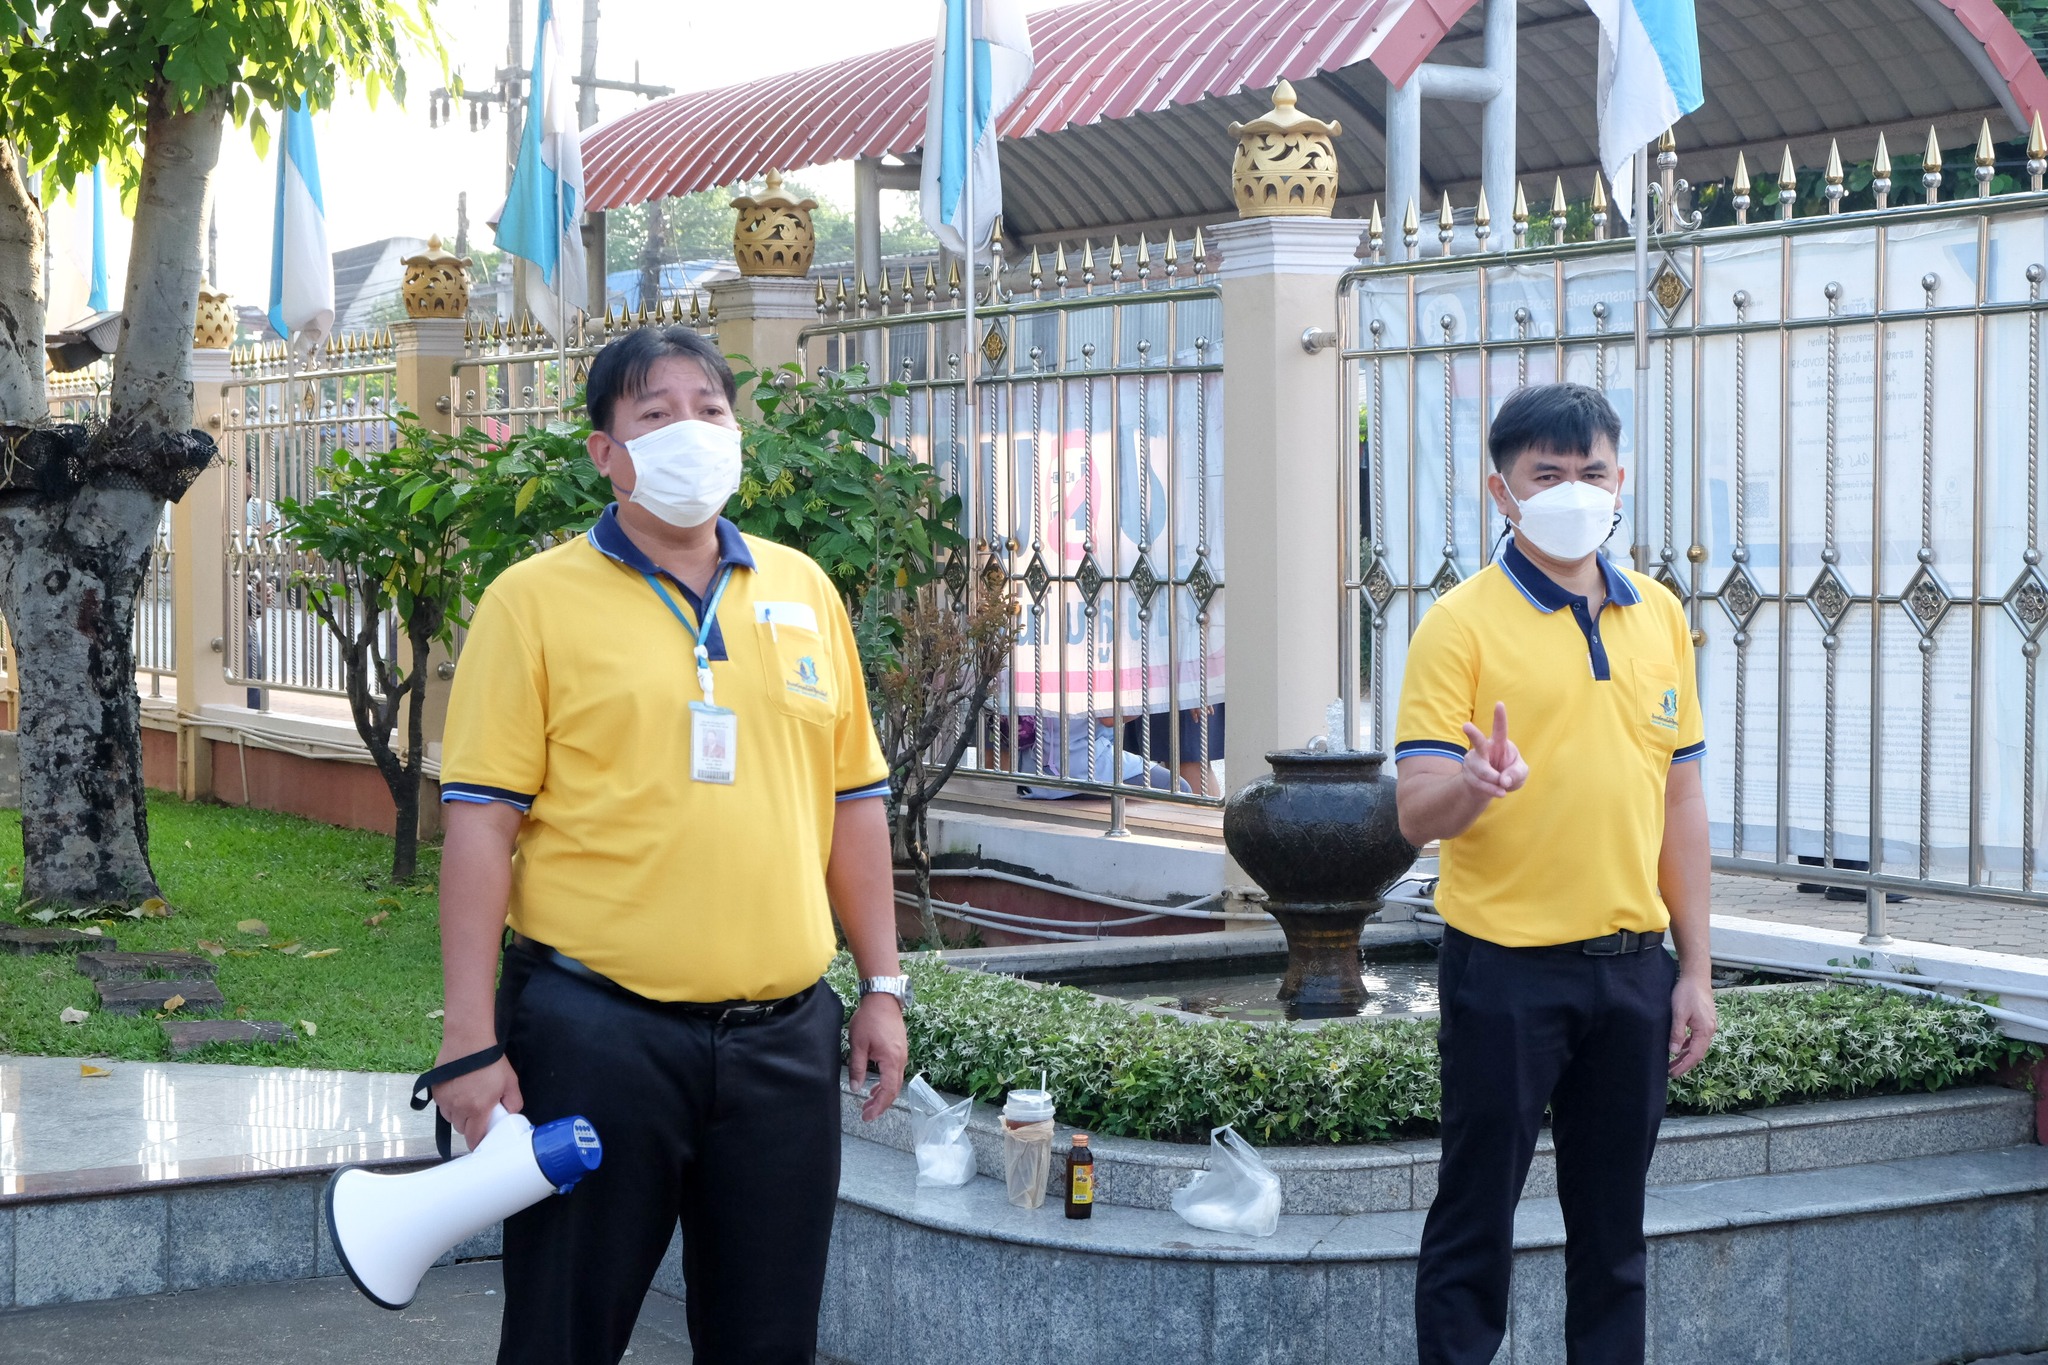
top-left (1395, 542), bottom-right (1706, 948)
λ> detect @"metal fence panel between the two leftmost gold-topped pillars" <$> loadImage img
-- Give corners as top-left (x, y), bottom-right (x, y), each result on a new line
top-left (221, 332), bottom-right (397, 696)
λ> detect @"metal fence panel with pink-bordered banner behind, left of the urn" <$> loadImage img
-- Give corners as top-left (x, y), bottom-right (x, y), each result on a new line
top-left (803, 237), bottom-right (1225, 806)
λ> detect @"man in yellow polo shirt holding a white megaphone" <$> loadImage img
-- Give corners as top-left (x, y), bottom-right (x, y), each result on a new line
top-left (422, 327), bottom-right (909, 1365)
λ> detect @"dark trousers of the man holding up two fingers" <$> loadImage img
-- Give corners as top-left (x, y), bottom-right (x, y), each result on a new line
top-left (1415, 929), bottom-right (1677, 1365)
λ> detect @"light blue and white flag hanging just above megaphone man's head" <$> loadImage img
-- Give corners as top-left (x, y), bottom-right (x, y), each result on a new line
top-left (492, 0), bottom-right (590, 338)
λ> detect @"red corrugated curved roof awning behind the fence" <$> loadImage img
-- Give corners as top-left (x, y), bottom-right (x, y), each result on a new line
top-left (584, 0), bottom-right (2048, 241)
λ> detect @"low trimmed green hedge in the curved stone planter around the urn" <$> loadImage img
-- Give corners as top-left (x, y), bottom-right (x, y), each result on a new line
top-left (829, 958), bottom-right (2040, 1144)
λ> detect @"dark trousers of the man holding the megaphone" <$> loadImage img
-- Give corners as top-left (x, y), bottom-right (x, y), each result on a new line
top-left (498, 948), bottom-right (844, 1365)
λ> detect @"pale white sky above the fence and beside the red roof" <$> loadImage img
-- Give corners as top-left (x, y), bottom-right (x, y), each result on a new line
top-left (49, 0), bottom-right (1055, 325)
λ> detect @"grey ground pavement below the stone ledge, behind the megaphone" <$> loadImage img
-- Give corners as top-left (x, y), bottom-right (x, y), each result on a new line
top-left (0, 1261), bottom-right (690, 1365)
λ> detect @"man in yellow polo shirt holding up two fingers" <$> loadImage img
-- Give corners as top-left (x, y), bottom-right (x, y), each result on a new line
top-left (1395, 385), bottom-right (1714, 1365)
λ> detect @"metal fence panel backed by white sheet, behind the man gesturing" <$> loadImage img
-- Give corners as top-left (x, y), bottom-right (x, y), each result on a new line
top-left (1341, 144), bottom-right (2048, 912)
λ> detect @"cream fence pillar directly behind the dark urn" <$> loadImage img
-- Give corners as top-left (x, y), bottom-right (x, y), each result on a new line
top-left (1208, 217), bottom-right (1358, 863)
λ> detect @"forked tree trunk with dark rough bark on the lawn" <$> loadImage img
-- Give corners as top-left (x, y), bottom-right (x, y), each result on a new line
top-left (0, 88), bottom-right (227, 907)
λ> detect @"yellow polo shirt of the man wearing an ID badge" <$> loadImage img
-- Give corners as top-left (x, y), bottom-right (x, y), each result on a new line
top-left (440, 508), bottom-right (889, 1003)
